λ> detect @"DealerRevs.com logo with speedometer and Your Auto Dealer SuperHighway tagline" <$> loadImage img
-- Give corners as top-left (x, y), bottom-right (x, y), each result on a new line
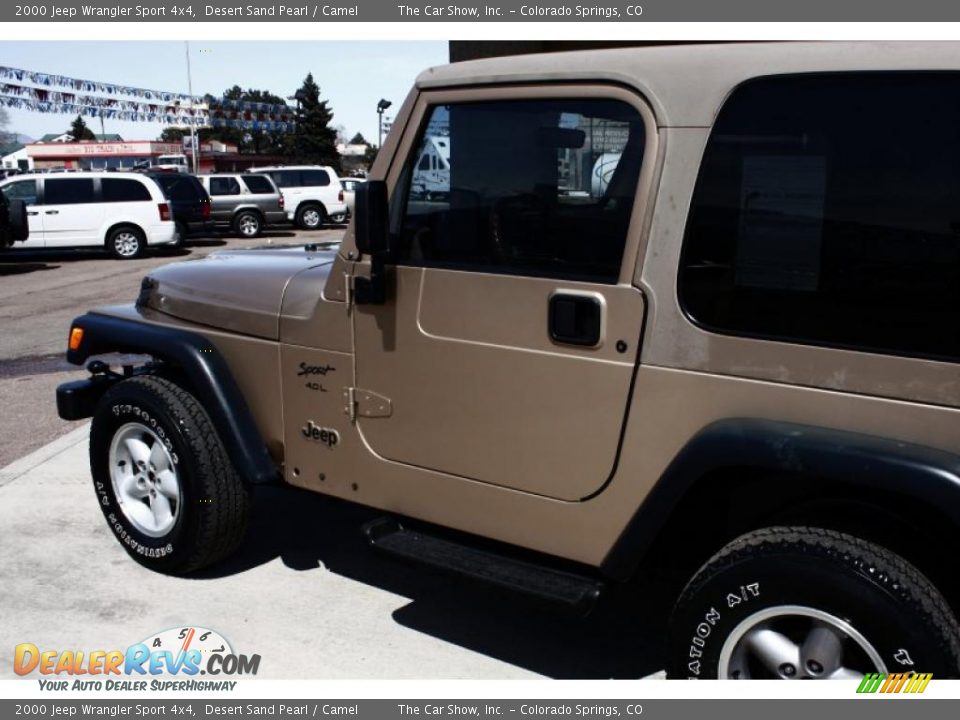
top-left (13, 627), bottom-right (260, 691)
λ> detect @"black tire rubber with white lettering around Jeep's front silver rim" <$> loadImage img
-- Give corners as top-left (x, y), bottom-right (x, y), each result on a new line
top-left (90, 376), bottom-right (250, 574)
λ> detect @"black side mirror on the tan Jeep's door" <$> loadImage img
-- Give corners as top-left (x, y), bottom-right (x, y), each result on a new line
top-left (353, 180), bottom-right (390, 305)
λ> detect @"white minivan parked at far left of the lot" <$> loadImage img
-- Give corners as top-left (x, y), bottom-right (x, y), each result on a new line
top-left (0, 172), bottom-right (176, 259)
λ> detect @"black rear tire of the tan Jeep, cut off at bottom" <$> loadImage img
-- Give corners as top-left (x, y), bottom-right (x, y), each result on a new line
top-left (667, 527), bottom-right (960, 679)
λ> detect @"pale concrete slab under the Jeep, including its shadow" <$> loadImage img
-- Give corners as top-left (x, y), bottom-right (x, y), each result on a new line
top-left (0, 426), bottom-right (656, 679)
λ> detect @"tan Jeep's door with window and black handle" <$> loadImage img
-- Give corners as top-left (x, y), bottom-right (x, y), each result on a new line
top-left (354, 87), bottom-right (656, 501)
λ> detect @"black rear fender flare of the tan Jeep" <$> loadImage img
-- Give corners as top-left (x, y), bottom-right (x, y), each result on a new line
top-left (601, 418), bottom-right (960, 580)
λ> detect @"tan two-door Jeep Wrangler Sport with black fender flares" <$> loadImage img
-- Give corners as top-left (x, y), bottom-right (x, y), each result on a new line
top-left (57, 43), bottom-right (960, 679)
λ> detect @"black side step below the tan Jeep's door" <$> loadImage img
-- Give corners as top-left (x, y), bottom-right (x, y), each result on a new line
top-left (363, 518), bottom-right (604, 615)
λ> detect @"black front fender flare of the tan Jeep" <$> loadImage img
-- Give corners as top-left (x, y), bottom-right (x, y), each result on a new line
top-left (67, 313), bottom-right (278, 484)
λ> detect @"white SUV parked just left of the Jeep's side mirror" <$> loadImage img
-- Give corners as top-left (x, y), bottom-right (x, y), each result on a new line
top-left (250, 165), bottom-right (347, 230)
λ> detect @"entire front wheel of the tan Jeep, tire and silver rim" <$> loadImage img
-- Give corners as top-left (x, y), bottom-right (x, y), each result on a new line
top-left (90, 376), bottom-right (249, 573)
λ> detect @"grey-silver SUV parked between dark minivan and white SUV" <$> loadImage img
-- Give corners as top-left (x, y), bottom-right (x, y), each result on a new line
top-left (200, 173), bottom-right (287, 237)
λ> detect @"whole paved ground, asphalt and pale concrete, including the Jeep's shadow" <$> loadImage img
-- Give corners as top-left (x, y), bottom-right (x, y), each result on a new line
top-left (0, 229), bottom-right (659, 679)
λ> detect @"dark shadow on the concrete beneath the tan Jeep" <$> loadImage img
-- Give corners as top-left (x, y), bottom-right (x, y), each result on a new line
top-left (202, 487), bottom-right (663, 679)
